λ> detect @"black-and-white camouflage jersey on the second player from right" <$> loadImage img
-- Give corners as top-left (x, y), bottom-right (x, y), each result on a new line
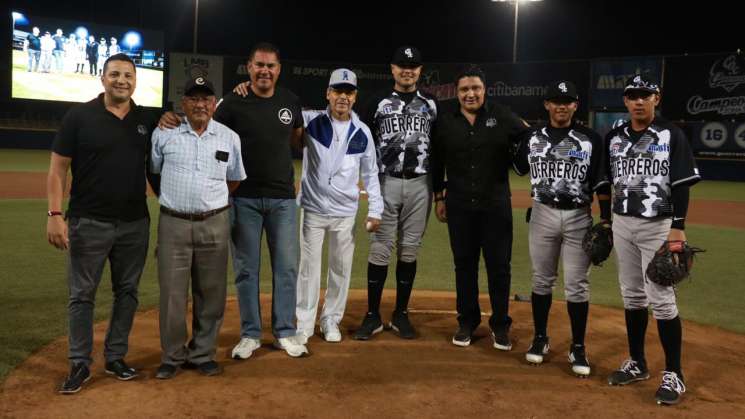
top-left (523, 124), bottom-right (608, 209)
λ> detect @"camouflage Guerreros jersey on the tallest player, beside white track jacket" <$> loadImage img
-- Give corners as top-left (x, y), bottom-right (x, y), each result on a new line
top-left (361, 90), bottom-right (438, 177)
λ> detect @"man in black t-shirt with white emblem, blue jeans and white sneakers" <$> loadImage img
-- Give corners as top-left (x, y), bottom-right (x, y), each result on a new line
top-left (161, 43), bottom-right (308, 359)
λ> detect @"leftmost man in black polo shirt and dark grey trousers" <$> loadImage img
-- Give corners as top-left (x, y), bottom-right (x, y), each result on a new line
top-left (47, 54), bottom-right (154, 394)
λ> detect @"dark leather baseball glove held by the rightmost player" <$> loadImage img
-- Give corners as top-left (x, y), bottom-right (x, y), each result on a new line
top-left (647, 240), bottom-right (705, 286)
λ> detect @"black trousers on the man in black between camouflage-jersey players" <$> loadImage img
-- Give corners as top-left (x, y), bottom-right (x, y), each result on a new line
top-left (446, 201), bottom-right (512, 330)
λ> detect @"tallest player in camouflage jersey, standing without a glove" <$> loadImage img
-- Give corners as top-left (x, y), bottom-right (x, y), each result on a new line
top-left (354, 46), bottom-right (438, 340)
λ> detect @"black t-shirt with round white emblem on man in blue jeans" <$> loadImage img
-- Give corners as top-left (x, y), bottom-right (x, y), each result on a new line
top-left (214, 87), bottom-right (303, 199)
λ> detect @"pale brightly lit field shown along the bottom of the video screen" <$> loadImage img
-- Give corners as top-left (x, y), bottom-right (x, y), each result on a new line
top-left (11, 50), bottom-right (163, 108)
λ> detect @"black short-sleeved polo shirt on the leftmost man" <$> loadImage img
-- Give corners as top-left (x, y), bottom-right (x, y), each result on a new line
top-left (52, 93), bottom-right (156, 221)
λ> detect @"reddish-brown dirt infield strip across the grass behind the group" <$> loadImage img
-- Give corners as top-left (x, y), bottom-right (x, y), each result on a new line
top-left (0, 172), bottom-right (745, 229)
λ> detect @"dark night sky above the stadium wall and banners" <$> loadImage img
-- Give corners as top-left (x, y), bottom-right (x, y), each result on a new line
top-left (8, 0), bottom-right (745, 63)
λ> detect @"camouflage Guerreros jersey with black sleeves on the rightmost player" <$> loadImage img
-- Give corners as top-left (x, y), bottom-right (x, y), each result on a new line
top-left (606, 119), bottom-right (701, 218)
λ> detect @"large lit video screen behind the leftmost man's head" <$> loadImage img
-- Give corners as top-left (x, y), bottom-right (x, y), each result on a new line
top-left (11, 11), bottom-right (165, 107)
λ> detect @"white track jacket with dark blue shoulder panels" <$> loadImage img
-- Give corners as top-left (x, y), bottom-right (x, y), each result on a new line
top-left (298, 109), bottom-right (383, 219)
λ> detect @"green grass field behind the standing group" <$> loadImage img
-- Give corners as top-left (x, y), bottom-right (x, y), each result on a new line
top-left (0, 150), bottom-right (745, 381)
